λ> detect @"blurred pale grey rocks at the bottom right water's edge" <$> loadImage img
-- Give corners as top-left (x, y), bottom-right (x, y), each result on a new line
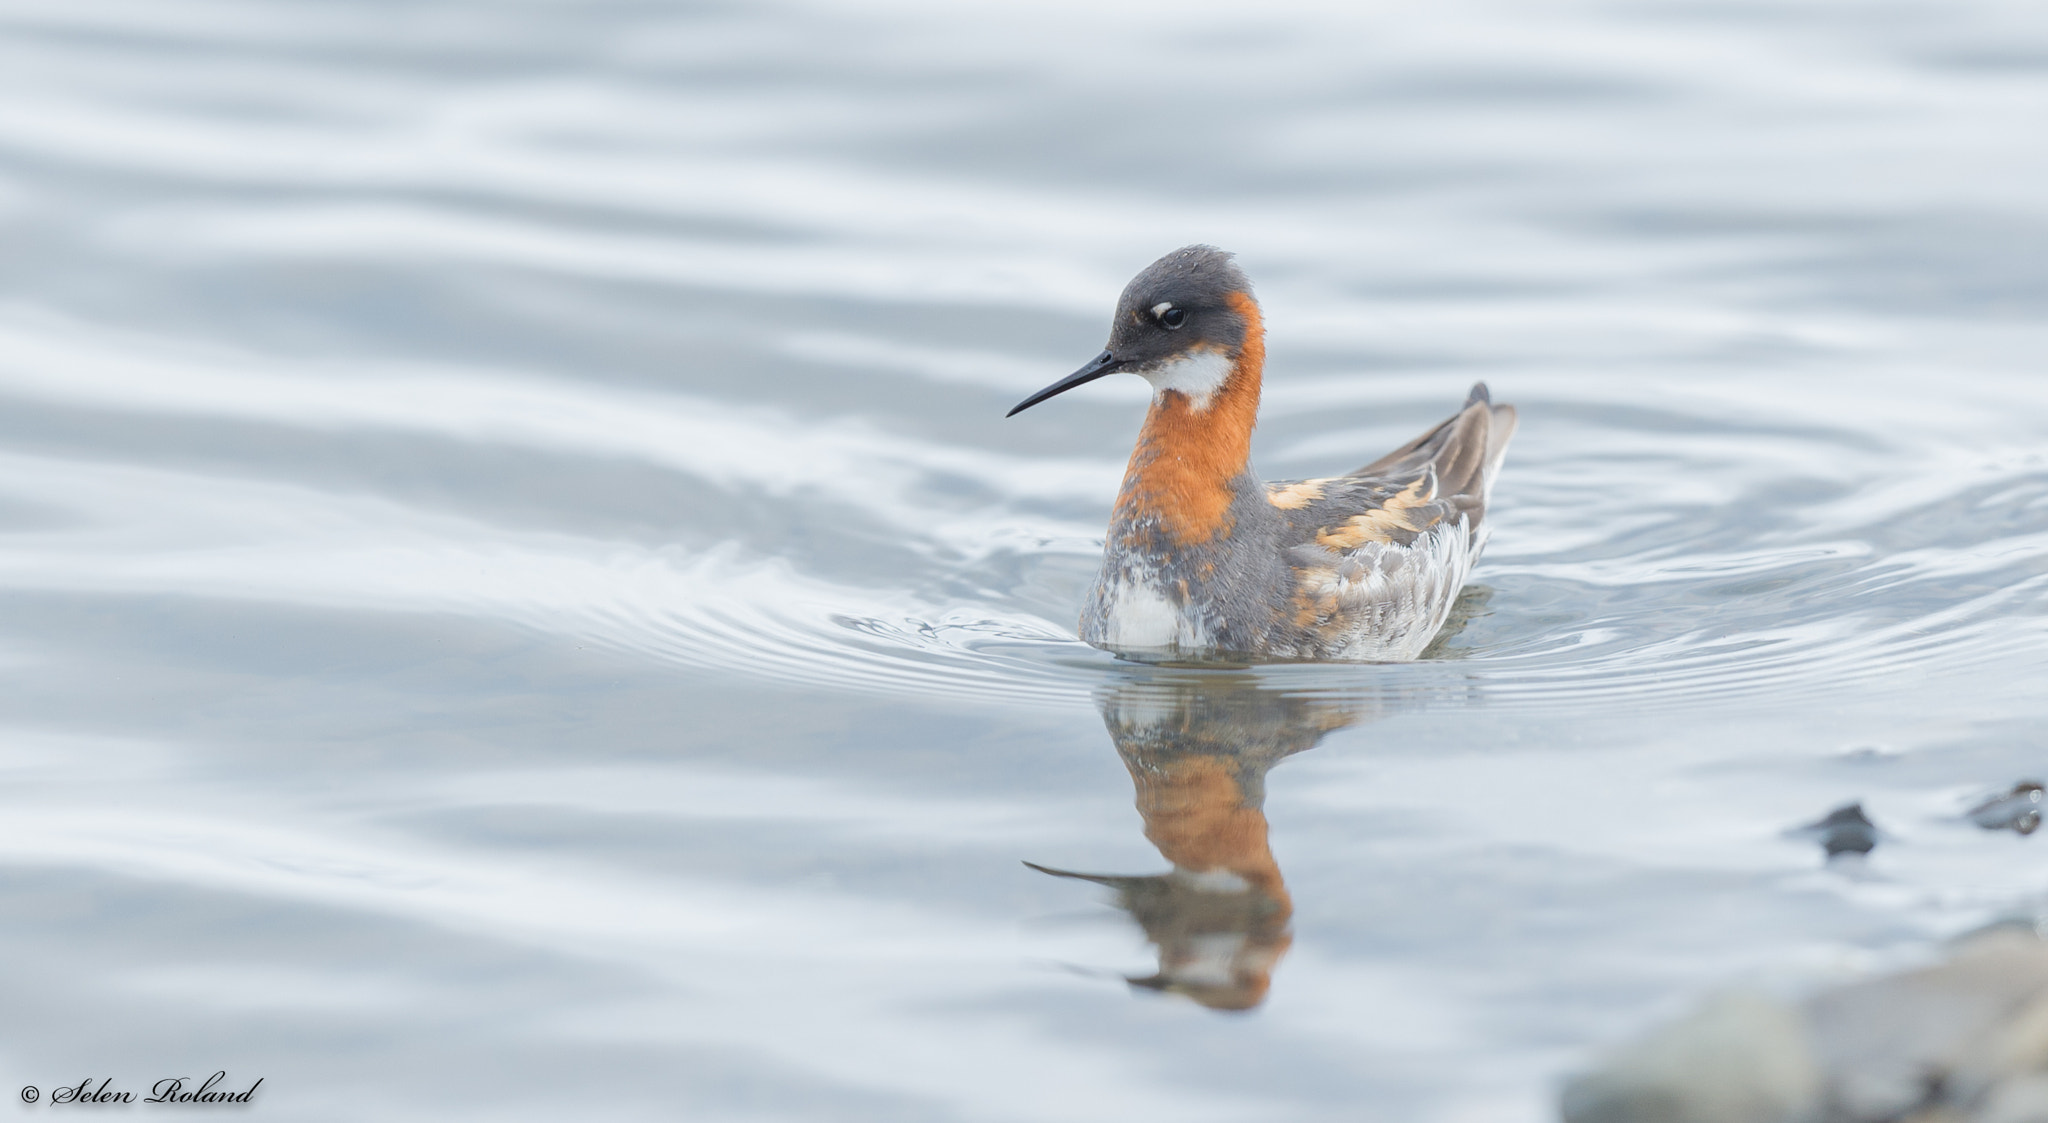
top-left (1563, 928), bottom-right (2048, 1123)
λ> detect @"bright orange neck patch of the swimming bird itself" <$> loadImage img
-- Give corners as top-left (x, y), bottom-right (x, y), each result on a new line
top-left (1116, 293), bottom-right (1266, 545)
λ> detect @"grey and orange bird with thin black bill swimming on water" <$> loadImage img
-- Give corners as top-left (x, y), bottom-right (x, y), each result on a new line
top-left (1008, 246), bottom-right (1516, 662)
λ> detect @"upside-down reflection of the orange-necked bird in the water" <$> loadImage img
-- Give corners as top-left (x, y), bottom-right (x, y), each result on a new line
top-left (1024, 674), bottom-right (1352, 1010)
